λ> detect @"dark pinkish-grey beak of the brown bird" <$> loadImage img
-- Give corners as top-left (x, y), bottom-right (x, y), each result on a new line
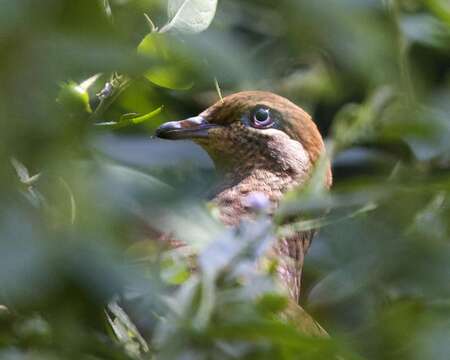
top-left (155, 116), bottom-right (218, 140)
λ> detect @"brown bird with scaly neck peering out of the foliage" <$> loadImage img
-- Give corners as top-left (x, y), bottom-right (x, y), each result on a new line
top-left (155, 91), bottom-right (332, 303)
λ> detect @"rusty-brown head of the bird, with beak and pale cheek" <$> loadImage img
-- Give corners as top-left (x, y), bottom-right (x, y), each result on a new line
top-left (156, 91), bottom-right (331, 185)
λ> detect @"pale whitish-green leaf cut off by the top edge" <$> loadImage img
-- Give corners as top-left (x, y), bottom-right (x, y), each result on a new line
top-left (160, 0), bottom-right (217, 34)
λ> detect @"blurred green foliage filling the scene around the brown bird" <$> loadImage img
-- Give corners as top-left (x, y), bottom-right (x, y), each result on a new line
top-left (0, 0), bottom-right (450, 360)
